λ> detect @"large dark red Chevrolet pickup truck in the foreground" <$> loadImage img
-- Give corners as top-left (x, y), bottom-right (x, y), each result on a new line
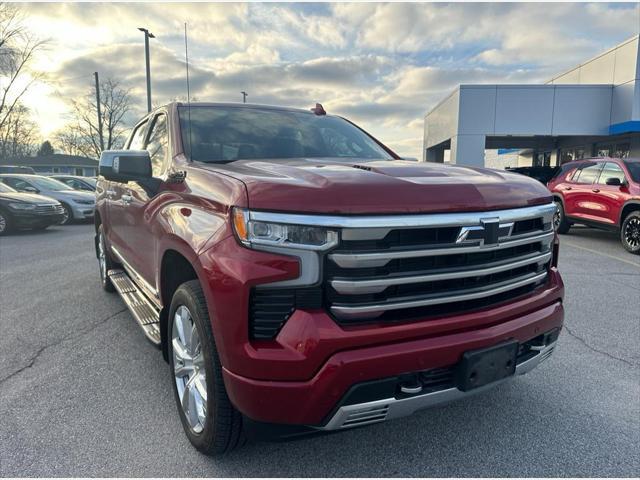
top-left (95, 103), bottom-right (564, 454)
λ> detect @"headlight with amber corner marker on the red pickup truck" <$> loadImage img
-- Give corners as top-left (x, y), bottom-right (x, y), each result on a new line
top-left (232, 207), bottom-right (338, 250)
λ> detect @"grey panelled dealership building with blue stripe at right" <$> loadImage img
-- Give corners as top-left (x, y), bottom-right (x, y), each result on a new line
top-left (423, 35), bottom-right (640, 168)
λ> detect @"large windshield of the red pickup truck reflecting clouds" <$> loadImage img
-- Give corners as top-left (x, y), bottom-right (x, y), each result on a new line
top-left (179, 106), bottom-right (393, 163)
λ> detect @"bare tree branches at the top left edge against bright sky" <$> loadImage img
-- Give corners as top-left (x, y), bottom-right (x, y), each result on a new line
top-left (0, 3), bottom-right (45, 134)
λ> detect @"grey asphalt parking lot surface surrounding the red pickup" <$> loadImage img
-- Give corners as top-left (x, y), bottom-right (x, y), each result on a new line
top-left (0, 225), bottom-right (640, 477)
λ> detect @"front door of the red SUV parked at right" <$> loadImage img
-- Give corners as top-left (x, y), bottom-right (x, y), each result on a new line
top-left (589, 162), bottom-right (629, 225)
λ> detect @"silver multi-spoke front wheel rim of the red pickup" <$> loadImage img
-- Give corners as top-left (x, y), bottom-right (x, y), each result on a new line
top-left (171, 305), bottom-right (207, 433)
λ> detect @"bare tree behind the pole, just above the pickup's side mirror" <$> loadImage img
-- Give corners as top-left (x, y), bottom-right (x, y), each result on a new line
top-left (56, 79), bottom-right (131, 158)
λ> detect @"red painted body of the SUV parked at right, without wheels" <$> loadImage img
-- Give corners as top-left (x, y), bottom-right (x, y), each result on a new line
top-left (548, 158), bottom-right (640, 227)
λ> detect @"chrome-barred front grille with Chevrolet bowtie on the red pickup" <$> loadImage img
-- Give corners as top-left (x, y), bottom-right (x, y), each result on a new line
top-left (324, 204), bottom-right (555, 324)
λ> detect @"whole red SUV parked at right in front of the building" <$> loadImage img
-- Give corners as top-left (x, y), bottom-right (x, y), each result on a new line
top-left (548, 158), bottom-right (640, 254)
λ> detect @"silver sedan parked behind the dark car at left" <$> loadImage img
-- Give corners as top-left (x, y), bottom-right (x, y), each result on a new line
top-left (0, 173), bottom-right (96, 225)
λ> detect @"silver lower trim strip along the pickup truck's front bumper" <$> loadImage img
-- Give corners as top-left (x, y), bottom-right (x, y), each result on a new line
top-left (313, 342), bottom-right (557, 430)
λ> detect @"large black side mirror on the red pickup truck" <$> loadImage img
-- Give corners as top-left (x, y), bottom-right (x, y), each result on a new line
top-left (98, 150), bottom-right (151, 183)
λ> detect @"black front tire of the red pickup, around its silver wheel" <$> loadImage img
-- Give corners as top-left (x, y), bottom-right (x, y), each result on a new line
top-left (167, 280), bottom-right (246, 455)
